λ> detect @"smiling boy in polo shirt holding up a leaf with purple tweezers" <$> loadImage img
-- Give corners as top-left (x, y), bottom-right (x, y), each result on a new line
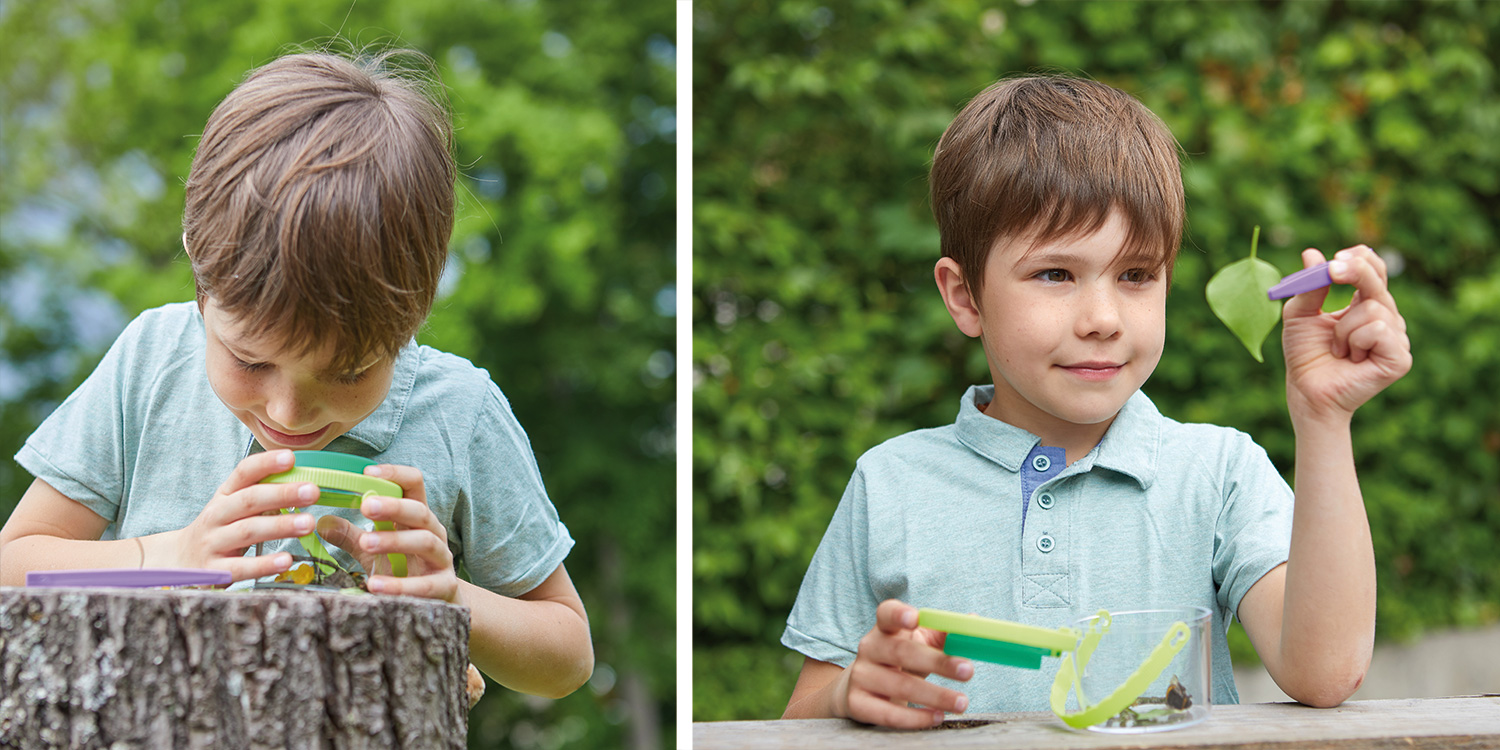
top-left (782, 78), bottom-right (1412, 728)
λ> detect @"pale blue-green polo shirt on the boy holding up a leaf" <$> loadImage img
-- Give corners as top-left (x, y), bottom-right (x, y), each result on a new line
top-left (782, 386), bottom-right (1292, 711)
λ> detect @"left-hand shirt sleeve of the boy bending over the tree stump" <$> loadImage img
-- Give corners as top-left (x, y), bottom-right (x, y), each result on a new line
top-left (15, 318), bottom-right (146, 522)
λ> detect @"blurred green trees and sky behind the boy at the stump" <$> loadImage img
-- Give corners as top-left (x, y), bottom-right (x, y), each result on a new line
top-left (0, 0), bottom-right (677, 749)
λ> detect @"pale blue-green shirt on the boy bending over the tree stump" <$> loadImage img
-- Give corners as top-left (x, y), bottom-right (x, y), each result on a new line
top-left (15, 302), bottom-right (573, 597)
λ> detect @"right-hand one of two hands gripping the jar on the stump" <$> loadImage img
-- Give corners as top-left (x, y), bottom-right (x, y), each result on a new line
top-left (318, 464), bottom-right (464, 605)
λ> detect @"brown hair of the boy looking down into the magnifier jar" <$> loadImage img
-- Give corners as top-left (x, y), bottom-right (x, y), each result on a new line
top-left (183, 51), bottom-right (456, 372)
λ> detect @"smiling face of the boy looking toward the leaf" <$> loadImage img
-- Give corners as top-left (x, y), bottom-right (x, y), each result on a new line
top-left (960, 212), bottom-right (1167, 444)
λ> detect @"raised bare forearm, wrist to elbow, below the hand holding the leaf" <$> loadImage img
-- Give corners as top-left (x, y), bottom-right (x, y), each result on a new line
top-left (1268, 411), bottom-right (1376, 705)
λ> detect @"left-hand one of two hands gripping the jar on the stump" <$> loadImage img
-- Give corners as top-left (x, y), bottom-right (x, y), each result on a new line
top-left (154, 450), bottom-right (318, 581)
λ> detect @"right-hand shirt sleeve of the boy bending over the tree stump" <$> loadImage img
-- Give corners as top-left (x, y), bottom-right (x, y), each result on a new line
top-left (455, 383), bottom-right (573, 597)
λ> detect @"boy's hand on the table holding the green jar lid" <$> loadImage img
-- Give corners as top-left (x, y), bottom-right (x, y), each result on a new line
top-left (834, 599), bottom-right (974, 729)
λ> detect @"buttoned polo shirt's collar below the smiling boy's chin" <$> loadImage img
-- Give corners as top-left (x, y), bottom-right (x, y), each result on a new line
top-left (954, 386), bottom-right (1163, 489)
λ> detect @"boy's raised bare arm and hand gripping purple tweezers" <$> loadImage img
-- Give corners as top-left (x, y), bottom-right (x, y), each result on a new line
top-left (1239, 246), bottom-right (1412, 707)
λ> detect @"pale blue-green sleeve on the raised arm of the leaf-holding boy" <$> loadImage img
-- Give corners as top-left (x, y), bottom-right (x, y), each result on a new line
top-left (1214, 434), bottom-right (1293, 617)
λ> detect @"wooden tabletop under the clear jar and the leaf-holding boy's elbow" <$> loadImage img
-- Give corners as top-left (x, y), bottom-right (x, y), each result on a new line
top-left (693, 695), bottom-right (1500, 750)
